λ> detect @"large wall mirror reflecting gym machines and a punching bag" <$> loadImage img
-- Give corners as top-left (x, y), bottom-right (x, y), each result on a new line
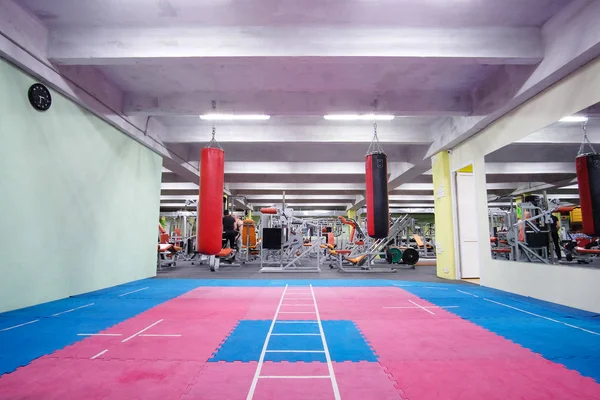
top-left (485, 103), bottom-right (600, 268)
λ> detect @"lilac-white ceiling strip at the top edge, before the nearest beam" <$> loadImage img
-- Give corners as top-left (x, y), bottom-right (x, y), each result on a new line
top-left (20, 0), bottom-right (567, 27)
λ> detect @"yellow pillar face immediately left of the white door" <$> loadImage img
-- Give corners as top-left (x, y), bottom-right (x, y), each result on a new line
top-left (431, 151), bottom-right (456, 279)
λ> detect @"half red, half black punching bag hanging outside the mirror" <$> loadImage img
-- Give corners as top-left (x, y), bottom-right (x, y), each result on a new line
top-left (365, 153), bottom-right (390, 239)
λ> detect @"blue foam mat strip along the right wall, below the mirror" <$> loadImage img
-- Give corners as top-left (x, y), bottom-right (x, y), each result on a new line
top-left (402, 286), bottom-right (600, 382)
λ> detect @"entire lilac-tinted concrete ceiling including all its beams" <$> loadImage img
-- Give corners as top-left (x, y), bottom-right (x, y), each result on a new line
top-left (0, 0), bottom-right (600, 216)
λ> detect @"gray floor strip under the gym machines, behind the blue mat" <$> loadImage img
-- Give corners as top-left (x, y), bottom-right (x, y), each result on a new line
top-left (157, 261), bottom-right (464, 284)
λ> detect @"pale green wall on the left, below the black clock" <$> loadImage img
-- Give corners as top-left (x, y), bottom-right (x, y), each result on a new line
top-left (0, 59), bottom-right (162, 312)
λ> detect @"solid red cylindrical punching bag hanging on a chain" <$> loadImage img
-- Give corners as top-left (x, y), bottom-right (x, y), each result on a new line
top-left (196, 147), bottom-right (225, 256)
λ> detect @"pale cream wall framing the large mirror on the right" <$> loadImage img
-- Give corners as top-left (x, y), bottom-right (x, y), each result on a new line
top-left (450, 58), bottom-right (600, 312)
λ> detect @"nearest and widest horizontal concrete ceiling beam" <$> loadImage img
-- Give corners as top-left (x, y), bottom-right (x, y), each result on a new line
top-left (49, 26), bottom-right (544, 65)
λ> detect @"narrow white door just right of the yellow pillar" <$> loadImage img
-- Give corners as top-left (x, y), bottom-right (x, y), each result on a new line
top-left (456, 172), bottom-right (479, 278)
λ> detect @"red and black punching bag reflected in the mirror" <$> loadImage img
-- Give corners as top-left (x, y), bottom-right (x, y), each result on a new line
top-left (575, 153), bottom-right (600, 236)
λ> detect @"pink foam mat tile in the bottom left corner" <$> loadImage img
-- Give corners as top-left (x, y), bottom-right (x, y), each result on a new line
top-left (0, 359), bottom-right (203, 400)
